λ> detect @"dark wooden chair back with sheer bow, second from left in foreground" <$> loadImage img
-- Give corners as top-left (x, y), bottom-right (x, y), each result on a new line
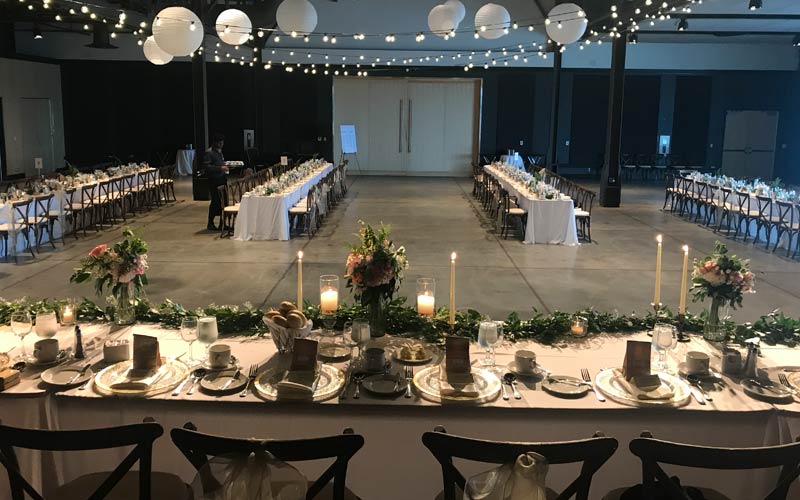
top-left (170, 422), bottom-right (364, 500)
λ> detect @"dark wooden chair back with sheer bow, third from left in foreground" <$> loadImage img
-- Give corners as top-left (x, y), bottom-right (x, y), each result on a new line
top-left (422, 427), bottom-right (619, 500)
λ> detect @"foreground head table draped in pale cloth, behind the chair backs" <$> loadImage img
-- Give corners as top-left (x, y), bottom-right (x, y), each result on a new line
top-left (0, 324), bottom-right (800, 500)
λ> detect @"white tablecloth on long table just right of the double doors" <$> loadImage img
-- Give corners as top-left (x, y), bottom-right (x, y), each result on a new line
top-left (483, 165), bottom-right (578, 246)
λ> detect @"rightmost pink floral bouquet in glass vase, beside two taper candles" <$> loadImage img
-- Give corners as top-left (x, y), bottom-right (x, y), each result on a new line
top-left (691, 242), bottom-right (755, 340)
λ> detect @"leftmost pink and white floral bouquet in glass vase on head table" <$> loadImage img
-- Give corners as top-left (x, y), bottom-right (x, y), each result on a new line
top-left (69, 228), bottom-right (148, 324)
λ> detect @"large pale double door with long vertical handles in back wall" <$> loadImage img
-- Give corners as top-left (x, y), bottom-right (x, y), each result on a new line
top-left (334, 78), bottom-right (480, 176)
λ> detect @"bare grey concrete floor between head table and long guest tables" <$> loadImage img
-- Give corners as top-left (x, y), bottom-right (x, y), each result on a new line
top-left (0, 177), bottom-right (800, 321)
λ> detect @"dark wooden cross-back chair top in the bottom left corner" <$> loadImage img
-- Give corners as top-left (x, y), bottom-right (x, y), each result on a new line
top-left (0, 422), bottom-right (164, 500)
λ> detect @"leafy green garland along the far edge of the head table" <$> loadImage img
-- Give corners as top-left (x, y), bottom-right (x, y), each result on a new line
top-left (0, 297), bottom-right (800, 347)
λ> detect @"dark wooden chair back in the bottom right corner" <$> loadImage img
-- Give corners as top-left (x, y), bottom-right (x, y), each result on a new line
top-left (629, 431), bottom-right (800, 500)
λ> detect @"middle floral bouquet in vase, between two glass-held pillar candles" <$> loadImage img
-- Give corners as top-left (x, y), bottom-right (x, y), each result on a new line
top-left (344, 221), bottom-right (408, 336)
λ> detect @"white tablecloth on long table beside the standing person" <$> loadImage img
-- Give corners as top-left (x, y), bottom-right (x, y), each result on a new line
top-left (233, 163), bottom-right (333, 241)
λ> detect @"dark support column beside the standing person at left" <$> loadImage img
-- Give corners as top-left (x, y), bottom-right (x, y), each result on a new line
top-left (192, 0), bottom-right (209, 200)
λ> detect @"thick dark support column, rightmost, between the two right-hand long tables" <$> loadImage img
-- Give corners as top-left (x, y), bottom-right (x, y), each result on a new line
top-left (600, 36), bottom-right (628, 207)
